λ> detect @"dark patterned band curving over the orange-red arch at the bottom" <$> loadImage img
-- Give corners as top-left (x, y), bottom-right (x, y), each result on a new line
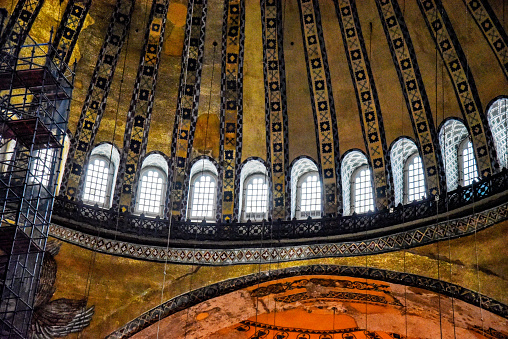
top-left (106, 265), bottom-right (508, 339)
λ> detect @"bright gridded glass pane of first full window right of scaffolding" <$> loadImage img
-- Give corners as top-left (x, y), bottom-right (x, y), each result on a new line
top-left (83, 158), bottom-right (109, 204)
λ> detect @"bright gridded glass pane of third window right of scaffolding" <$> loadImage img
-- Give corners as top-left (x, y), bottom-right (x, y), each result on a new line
top-left (191, 174), bottom-right (215, 218)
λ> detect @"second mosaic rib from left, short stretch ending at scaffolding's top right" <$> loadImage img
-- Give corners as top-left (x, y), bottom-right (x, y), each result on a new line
top-left (53, 0), bottom-right (92, 65)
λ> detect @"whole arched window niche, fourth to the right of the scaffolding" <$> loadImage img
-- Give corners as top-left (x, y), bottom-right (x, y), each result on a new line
top-left (238, 159), bottom-right (270, 221)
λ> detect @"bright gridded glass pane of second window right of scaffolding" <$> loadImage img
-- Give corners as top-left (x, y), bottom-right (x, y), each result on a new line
top-left (138, 169), bottom-right (164, 214)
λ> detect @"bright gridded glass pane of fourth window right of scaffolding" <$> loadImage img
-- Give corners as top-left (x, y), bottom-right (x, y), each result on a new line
top-left (245, 176), bottom-right (268, 220)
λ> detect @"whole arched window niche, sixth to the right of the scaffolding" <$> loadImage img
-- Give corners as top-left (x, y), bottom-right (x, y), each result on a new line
top-left (341, 150), bottom-right (374, 215)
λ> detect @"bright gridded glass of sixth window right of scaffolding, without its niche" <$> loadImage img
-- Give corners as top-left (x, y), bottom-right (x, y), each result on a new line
top-left (351, 165), bottom-right (374, 213)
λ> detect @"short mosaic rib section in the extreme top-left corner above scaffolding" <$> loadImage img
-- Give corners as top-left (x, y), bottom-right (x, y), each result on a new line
top-left (0, 0), bottom-right (44, 65)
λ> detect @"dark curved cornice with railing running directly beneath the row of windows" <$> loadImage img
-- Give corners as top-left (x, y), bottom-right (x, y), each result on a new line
top-left (52, 169), bottom-right (508, 249)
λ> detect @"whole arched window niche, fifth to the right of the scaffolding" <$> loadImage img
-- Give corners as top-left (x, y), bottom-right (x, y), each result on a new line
top-left (291, 158), bottom-right (322, 219)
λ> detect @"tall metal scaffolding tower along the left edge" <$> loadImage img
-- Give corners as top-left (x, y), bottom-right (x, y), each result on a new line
top-left (0, 31), bottom-right (74, 338)
